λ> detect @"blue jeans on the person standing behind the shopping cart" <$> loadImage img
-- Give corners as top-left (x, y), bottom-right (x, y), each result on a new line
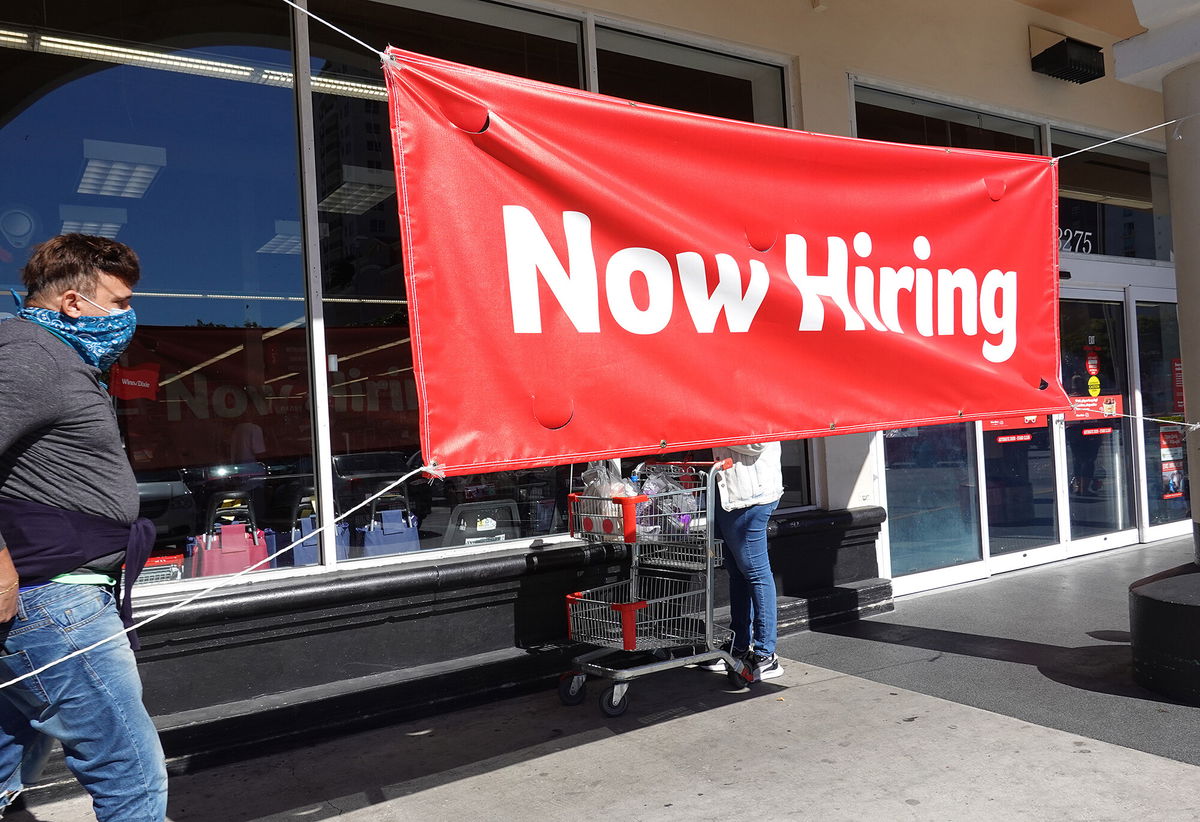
top-left (715, 500), bottom-right (779, 655)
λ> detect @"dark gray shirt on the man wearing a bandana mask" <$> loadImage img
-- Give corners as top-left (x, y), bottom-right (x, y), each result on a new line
top-left (0, 319), bottom-right (138, 545)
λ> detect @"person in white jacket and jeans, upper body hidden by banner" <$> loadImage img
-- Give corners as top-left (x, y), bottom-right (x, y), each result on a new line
top-left (704, 443), bottom-right (784, 680)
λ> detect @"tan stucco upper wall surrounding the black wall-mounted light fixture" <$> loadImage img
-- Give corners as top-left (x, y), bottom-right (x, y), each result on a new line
top-left (580, 0), bottom-right (1163, 142)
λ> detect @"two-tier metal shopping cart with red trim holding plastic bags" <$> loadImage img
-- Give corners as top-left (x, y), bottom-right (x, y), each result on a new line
top-left (558, 462), bottom-right (749, 716)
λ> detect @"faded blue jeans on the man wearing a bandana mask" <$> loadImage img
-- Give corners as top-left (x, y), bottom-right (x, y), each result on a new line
top-left (0, 582), bottom-right (167, 822)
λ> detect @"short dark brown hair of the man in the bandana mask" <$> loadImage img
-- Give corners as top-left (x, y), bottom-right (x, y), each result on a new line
top-left (20, 234), bottom-right (142, 301)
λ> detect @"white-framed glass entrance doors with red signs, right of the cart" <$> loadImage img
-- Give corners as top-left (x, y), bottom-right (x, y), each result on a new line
top-left (880, 287), bottom-right (1190, 594)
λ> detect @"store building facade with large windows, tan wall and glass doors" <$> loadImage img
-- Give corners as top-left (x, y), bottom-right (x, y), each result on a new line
top-left (0, 0), bottom-right (1192, 754)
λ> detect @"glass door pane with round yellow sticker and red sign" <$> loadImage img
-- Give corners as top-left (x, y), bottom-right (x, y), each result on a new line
top-left (1060, 300), bottom-right (1133, 539)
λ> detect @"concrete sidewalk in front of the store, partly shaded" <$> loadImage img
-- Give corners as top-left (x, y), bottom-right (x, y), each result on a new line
top-left (5, 540), bottom-right (1200, 822)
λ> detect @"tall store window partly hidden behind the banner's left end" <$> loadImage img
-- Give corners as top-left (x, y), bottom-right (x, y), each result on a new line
top-left (310, 0), bottom-right (581, 559)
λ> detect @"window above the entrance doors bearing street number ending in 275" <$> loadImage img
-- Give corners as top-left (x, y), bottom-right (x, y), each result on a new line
top-left (1050, 130), bottom-right (1172, 260)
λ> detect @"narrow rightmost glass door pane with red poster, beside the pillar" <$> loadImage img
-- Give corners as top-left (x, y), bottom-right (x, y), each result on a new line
top-left (1138, 302), bottom-right (1192, 526)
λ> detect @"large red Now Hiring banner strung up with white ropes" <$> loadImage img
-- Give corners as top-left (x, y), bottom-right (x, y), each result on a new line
top-left (384, 50), bottom-right (1069, 473)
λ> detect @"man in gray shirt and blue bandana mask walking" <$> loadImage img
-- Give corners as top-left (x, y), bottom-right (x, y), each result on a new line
top-left (0, 234), bottom-right (167, 822)
